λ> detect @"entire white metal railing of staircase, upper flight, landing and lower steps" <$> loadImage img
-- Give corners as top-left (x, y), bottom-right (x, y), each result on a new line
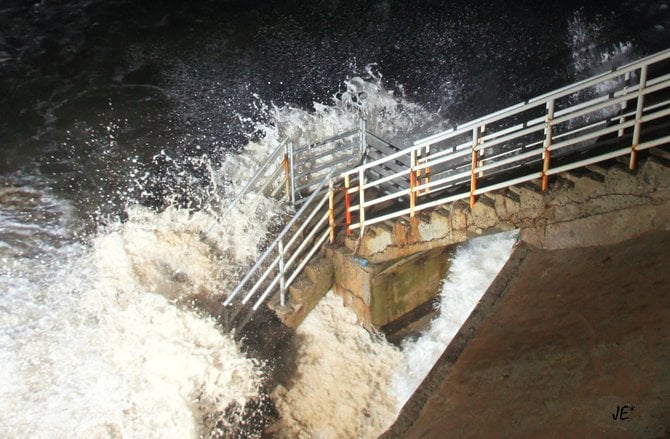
top-left (223, 49), bottom-right (670, 324)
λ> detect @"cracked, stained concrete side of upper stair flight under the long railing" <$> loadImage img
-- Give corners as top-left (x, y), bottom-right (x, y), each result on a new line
top-left (345, 157), bottom-right (670, 263)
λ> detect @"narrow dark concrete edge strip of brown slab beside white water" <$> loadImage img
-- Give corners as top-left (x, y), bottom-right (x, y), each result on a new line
top-left (380, 242), bottom-right (533, 439)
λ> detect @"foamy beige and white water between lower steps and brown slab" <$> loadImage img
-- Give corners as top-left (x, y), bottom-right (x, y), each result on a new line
top-left (272, 232), bottom-right (518, 438)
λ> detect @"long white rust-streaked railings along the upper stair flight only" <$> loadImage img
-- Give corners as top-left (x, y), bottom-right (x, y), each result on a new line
top-left (338, 49), bottom-right (670, 237)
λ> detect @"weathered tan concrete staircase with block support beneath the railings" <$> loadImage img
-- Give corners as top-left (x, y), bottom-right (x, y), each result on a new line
top-left (284, 146), bottom-right (670, 328)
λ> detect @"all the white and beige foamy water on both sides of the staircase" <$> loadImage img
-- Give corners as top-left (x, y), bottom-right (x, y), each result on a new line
top-left (0, 13), bottom-right (640, 437)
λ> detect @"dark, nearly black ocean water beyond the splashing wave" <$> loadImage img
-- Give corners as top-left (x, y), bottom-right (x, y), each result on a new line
top-left (0, 0), bottom-right (670, 213)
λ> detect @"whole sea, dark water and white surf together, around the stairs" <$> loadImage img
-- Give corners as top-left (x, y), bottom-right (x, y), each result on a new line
top-left (0, 0), bottom-right (670, 438)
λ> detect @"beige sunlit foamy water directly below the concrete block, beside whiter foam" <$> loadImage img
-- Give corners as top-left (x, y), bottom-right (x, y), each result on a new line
top-left (272, 292), bottom-right (401, 439)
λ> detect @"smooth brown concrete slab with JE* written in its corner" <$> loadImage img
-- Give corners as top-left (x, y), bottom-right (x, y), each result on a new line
top-left (383, 231), bottom-right (670, 438)
